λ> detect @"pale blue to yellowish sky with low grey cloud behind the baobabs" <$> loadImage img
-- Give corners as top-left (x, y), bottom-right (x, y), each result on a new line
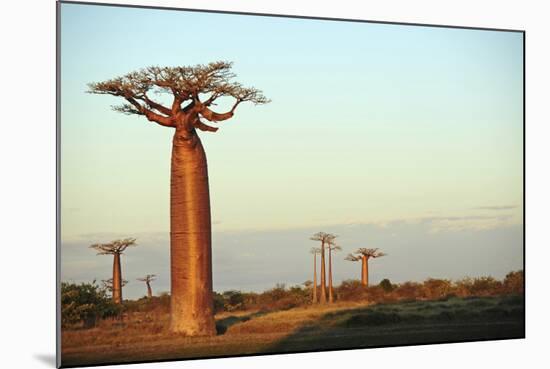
top-left (60, 3), bottom-right (523, 298)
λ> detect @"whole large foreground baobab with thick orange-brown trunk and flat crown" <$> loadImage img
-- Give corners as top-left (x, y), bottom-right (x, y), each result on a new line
top-left (89, 62), bottom-right (269, 336)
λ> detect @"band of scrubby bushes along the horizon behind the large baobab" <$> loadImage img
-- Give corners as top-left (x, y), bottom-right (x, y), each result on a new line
top-left (61, 271), bottom-right (524, 328)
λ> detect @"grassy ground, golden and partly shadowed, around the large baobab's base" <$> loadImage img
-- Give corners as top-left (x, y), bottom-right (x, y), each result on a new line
top-left (62, 296), bottom-right (525, 366)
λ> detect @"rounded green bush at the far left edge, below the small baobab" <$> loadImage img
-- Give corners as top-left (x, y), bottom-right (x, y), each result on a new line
top-left (61, 281), bottom-right (122, 328)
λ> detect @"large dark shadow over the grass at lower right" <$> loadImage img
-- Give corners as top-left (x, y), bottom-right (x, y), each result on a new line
top-left (266, 301), bottom-right (525, 353)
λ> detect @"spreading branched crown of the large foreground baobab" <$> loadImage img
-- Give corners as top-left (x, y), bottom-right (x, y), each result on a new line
top-left (88, 61), bottom-right (270, 132)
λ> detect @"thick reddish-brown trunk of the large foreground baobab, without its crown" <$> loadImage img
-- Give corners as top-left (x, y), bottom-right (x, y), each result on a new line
top-left (170, 131), bottom-right (216, 336)
